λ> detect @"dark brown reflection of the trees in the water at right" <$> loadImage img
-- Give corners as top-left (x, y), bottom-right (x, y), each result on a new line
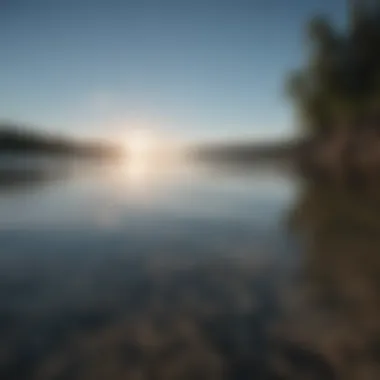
top-left (285, 184), bottom-right (380, 379)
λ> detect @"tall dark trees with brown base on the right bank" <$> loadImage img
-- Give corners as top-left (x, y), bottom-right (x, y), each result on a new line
top-left (287, 1), bottom-right (380, 177)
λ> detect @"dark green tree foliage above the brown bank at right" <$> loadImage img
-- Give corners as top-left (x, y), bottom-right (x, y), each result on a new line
top-left (287, 4), bottom-right (380, 133)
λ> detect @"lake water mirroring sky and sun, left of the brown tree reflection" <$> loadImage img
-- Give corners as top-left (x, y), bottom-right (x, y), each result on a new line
top-left (0, 161), bottom-right (358, 380)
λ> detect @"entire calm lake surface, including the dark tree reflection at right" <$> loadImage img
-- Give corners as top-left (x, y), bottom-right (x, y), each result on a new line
top-left (0, 159), bottom-right (380, 379)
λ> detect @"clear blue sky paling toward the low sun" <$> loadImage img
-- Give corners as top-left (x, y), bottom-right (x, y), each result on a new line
top-left (0, 0), bottom-right (345, 138)
